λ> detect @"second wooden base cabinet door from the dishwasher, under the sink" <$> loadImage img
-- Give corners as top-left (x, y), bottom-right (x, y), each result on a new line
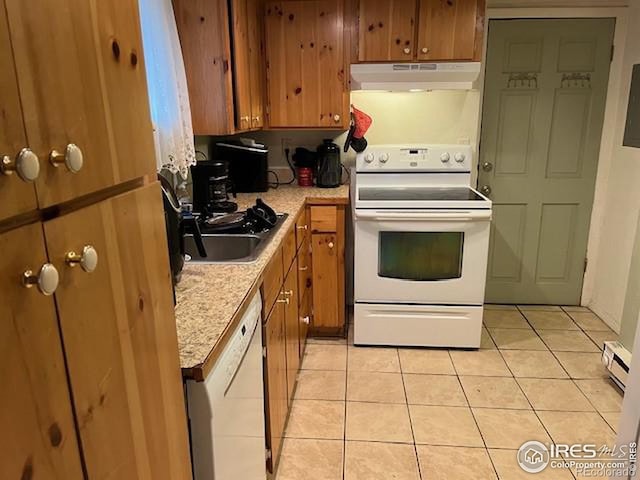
top-left (284, 260), bottom-right (300, 402)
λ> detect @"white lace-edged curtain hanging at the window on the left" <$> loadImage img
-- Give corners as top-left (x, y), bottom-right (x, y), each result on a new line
top-left (140, 0), bottom-right (196, 179)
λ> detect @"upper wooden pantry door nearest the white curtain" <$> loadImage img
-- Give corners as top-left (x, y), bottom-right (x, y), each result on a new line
top-left (5, 0), bottom-right (155, 207)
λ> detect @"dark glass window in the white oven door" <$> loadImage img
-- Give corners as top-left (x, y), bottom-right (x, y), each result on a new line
top-left (378, 232), bottom-right (464, 281)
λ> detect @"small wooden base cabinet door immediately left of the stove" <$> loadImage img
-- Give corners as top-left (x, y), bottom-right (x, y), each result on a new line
top-left (311, 233), bottom-right (343, 329)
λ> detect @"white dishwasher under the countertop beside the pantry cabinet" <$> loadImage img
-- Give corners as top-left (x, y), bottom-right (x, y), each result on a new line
top-left (187, 293), bottom-right (266, 480)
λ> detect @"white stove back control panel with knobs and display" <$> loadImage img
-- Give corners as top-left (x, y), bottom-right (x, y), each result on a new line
top-left (356, 145), bottom-right (473, 173)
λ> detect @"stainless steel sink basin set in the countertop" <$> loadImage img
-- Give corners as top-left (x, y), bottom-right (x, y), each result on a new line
top-left (184, 214), bottom-right (288, 263)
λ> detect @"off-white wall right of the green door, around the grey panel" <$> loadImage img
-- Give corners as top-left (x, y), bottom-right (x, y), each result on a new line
top-left (583, 0), bottom-right (640, 342)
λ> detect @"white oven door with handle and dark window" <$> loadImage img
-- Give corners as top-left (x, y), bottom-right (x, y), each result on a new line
top-left (355, 209), bottom-right (491, 305)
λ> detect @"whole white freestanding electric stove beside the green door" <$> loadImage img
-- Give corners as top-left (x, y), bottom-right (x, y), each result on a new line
top-left (352, 145), bottom-right (491, 348)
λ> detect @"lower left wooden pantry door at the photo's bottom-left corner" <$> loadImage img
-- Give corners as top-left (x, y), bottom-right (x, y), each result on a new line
top-left (0, 224), bottom-right (83, 480)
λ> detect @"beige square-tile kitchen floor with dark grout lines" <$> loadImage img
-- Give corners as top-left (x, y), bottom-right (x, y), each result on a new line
top-left (277, 305), bottom-right (622, 480)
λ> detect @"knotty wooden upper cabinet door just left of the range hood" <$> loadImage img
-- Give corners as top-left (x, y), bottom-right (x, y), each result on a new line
top-left (265, 0), bottom-right (349, 128)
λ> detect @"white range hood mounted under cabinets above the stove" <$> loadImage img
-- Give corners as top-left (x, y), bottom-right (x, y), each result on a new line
top-left (351, 62), bottom-right (480, 91)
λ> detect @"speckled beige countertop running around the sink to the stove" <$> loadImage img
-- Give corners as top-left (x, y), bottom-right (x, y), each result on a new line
top-left (175, 185), bottom-right (349, 378)
